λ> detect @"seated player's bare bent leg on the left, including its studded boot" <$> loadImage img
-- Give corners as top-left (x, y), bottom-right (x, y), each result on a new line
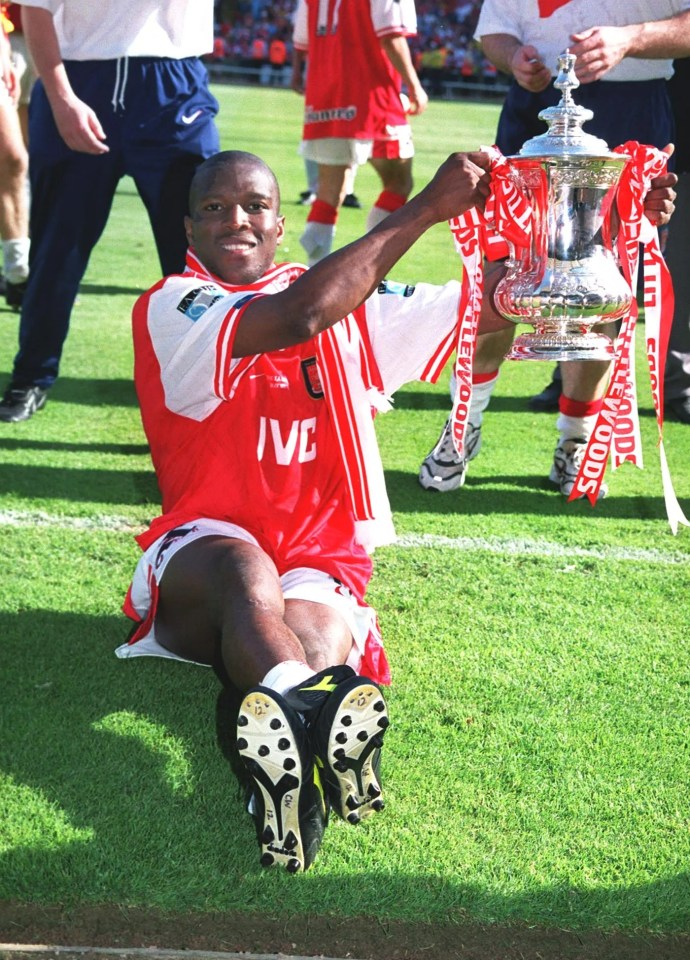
top-left (156, 536), bottom-right (352, 872)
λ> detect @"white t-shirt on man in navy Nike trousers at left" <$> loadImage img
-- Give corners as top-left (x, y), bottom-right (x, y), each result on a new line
top-left (17, 0), bottom-right (213, 60)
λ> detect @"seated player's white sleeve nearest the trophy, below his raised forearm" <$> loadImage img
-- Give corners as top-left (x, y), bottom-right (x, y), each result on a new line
top-left (365, 280), bottom-right (460, 394)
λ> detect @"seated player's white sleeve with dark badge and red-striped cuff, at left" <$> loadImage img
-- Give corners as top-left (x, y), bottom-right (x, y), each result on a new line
top-left (142, 276), bottom-right (256, 420)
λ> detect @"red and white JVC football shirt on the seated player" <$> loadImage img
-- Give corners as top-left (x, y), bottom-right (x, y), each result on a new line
top-left (133, 252), bottom-right (460, 599)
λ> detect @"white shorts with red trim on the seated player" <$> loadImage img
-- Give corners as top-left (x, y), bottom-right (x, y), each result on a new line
top-left (115, 519), bottom-right (390, 683)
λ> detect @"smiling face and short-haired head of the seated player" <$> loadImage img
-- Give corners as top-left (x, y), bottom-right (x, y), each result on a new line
top-left (185, 150), bottom-right (284, 286)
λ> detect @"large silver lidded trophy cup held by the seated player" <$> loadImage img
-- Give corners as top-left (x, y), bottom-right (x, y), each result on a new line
top-left (494, 52), bottom-right (632, 360)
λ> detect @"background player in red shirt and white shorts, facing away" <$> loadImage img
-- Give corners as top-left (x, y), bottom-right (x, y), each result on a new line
top-left (293, 0), bottom-right (428, 264)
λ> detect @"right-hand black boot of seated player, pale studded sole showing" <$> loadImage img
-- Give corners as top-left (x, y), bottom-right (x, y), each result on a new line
top-left (311, 676), bottom-right (390, 823)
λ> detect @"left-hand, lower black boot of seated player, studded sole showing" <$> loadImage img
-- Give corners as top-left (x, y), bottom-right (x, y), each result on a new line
top-left (237, 687), bottom-right (328, 873)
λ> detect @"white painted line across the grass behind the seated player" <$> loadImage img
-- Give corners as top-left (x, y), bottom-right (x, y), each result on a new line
top-left (0, 510), bottom-right (690, 565)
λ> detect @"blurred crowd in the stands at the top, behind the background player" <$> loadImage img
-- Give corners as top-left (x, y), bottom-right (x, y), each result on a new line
top-left (210, 0), bottom-right (497, 96)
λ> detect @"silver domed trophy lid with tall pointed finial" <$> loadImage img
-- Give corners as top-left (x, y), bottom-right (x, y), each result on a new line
top-left (518, 50), bottom-right (617, 157)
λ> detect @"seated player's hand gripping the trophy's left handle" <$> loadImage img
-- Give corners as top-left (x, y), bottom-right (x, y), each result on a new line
top-left (422, 152), bottom-right (491, 222)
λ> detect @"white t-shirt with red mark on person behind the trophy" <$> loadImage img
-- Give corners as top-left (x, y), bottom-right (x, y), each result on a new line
top-left (474, 0), bottom-right (690, 80)
